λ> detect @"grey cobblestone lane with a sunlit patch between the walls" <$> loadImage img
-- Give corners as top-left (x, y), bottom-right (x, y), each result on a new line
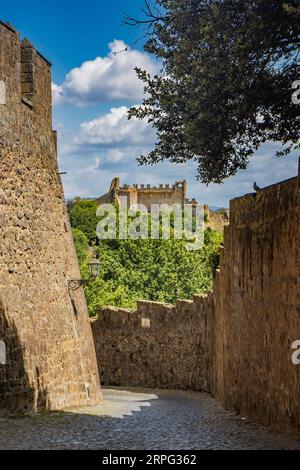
top-left (0, 389), bottom-right (300, 450)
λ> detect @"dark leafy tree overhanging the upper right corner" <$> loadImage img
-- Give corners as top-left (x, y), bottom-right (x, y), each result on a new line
top-left (126, 0), bottom-right (300, 184)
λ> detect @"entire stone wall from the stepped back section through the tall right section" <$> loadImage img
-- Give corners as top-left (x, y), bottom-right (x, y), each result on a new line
top-left (92, 167), bottom-right (300, 429)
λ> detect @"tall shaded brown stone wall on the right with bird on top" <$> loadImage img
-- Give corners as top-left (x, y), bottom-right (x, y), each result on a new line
top-left (214, 173), bottom-right (300, 427)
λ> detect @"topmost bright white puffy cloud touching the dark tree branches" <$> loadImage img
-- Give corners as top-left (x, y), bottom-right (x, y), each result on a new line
top-left (52, 40), bottom-right (159, 106)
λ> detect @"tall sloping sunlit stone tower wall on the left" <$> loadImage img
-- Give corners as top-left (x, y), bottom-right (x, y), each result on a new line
top-left (0, 22), bottom-right (101, 413)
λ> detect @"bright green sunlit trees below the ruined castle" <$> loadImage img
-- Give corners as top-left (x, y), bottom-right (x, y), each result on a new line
top-left (70, 201), bottom-right (223, 316)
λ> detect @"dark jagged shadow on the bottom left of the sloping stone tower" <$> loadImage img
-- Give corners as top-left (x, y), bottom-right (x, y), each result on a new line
top-left (0, 298), bottom-right (47, 416)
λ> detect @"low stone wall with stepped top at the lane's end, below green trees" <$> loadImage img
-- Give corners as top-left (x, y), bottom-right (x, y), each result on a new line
top-left (92, 296), bottom-right (212, 391)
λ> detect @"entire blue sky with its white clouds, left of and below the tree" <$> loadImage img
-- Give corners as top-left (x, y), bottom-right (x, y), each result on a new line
top-left (0, 0), bottom-right (298, 207)
